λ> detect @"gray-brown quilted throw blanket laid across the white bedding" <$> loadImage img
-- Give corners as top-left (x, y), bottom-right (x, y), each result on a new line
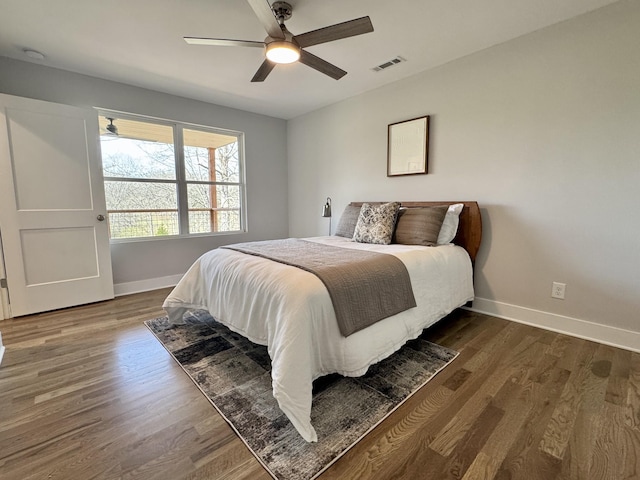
top-left (221, 238), bottom-right (416, 337)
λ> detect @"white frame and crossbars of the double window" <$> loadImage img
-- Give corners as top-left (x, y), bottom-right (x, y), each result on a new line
top-left (96, 108), bottom-right (247, 244)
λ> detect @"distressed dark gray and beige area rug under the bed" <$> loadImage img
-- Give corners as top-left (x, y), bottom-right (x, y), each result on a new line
top-left (145, 311), bottom-right (458, 480)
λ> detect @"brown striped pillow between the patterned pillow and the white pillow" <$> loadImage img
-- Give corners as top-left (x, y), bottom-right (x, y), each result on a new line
top-left (395, 205), bottom-right (448, 246)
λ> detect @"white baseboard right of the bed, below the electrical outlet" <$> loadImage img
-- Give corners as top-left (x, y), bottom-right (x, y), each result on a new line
top-left (468, 297), bottom-right (640, 352)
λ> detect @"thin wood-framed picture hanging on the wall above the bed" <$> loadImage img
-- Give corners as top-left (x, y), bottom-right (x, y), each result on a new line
top-left (387, 115), bottom-right (429, 177)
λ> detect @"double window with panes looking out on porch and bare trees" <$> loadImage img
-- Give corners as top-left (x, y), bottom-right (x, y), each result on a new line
top-left (100, 111), bottom-right (245, 239)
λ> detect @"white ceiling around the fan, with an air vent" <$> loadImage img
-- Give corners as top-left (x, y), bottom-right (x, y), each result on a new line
top-left (0, 0), bottom-right (616, 119)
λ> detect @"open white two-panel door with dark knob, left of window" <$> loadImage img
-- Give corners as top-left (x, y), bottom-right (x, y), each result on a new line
top-left (0, 94), bottom-right (113, 317)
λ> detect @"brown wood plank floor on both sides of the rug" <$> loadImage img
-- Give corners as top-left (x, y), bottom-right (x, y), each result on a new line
top-left (0, 290), bottom-right (640, 480)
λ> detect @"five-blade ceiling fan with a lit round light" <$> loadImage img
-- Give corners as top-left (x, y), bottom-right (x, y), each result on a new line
top-left (184, 0), bottom-right (373, 82)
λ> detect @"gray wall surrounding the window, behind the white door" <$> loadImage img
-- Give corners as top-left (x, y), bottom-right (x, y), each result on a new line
top-left (0, 57), bottom-right (288, 292)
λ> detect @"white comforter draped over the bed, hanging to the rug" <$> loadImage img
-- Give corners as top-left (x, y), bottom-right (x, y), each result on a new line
top-left (163, 236), bottom-right (473, 442)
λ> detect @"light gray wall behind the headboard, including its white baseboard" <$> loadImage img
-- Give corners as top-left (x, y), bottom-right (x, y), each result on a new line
top-left (287, 1), bottom-right (640, 349)
